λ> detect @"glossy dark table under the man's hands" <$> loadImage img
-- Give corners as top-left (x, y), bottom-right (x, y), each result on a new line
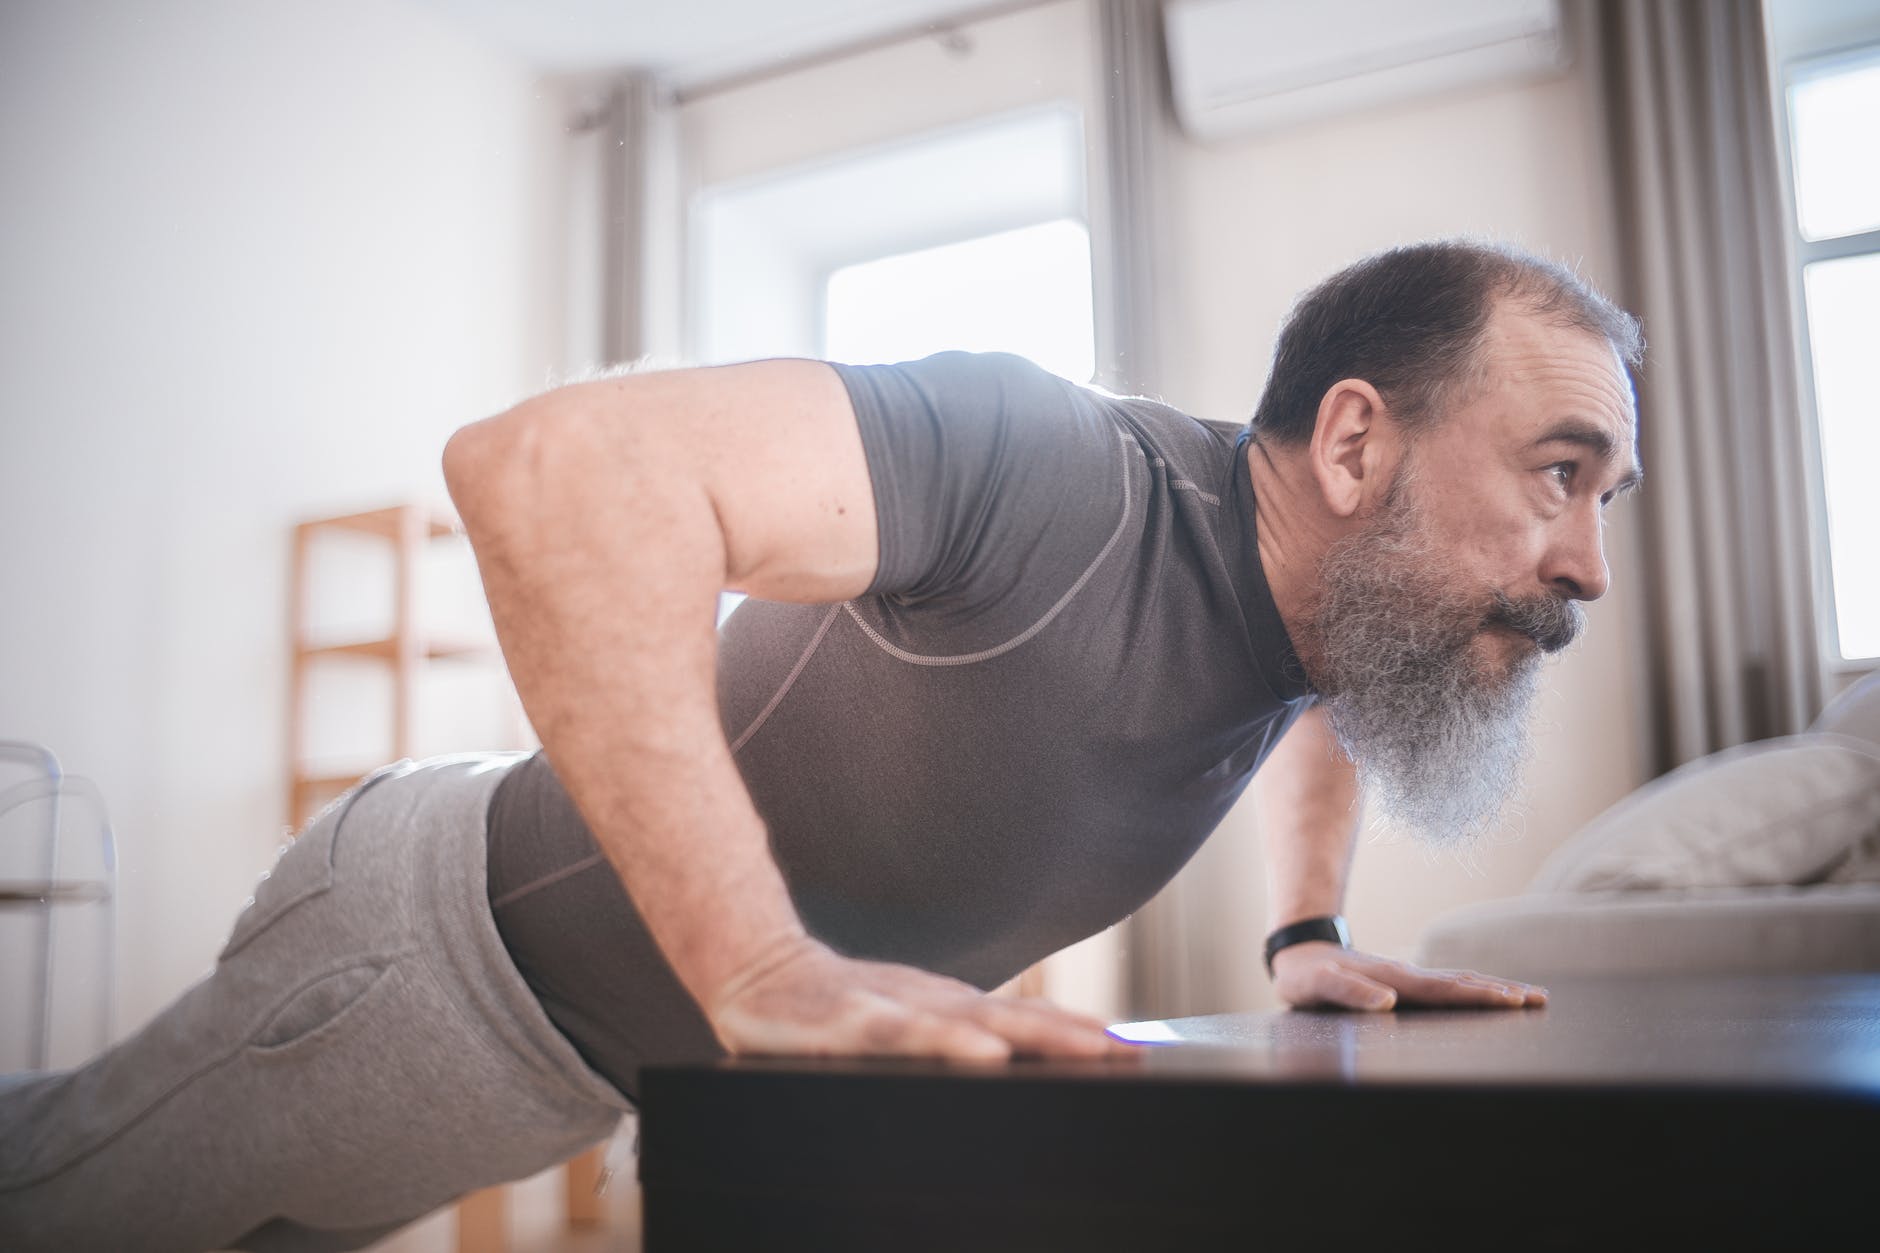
top-left (639, 975), bottom-right (1880, 1253)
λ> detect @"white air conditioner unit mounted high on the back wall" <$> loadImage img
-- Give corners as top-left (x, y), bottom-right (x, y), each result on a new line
top-left (1162, 0), bottom-right (1568, 139)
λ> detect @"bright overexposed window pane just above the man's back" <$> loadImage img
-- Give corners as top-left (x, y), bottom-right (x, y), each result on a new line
top-left (823, 218), bottom-right (1096, 382)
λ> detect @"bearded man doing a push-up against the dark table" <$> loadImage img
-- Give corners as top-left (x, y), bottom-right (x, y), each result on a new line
top-left (0, 243), bottom-right (1639, 1249)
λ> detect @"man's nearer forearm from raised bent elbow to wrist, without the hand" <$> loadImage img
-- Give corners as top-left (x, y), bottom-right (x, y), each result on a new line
top-left (446, 370), bottom-right (827, 1003)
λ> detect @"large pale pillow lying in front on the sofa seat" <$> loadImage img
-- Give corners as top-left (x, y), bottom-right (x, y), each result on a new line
top-left (1528, 732), bottom-right (1880, 892)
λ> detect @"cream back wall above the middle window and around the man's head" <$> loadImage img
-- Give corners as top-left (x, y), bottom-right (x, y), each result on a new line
top-left (682, 0), bottom-right (1645, 1012)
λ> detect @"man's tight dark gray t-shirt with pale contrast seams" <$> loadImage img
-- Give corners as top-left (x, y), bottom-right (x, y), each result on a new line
top-left (489, 354), bottom-right (1310, 1095)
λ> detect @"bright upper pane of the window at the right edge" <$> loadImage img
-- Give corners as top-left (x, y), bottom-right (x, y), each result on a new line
top-left (1790, 60), bottom-right (1880, 239)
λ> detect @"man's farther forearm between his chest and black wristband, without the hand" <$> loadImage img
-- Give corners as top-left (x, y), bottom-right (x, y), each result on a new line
top-left (1254, 707), bottom-right (1357, 929)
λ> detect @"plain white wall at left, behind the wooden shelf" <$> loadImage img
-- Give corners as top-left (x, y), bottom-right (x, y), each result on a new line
top-left (0, 0), bottom-right (564, 1033)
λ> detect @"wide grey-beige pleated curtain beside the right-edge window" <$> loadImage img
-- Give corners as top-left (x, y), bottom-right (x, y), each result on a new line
top-left (1589, 0), bottom-right (1822, 769)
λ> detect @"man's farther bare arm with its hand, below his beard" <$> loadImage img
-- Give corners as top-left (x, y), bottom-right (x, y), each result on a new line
top-left (1254, 707), bottom-right (1547, 1010)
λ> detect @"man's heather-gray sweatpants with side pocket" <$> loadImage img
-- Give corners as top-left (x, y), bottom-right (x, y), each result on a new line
top-left (0, 754), bottom-right (628, 1253)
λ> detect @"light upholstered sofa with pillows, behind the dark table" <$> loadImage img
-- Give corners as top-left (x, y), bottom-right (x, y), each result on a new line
top-left (1416, 674), bottom-right (1880, 982)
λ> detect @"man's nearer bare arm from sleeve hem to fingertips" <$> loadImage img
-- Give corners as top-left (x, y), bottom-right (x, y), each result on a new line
top-left (444, 361), bottom-right (1115, 1059)
